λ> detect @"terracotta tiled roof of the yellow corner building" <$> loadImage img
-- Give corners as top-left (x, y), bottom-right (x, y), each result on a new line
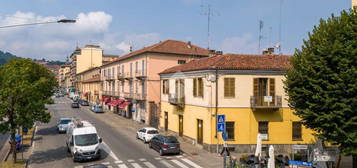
top-left (160, 54), bottom-right (291, 74)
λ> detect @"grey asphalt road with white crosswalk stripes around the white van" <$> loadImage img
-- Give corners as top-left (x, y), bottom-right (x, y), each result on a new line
top-left (30, 98), bottom-right (207, 168)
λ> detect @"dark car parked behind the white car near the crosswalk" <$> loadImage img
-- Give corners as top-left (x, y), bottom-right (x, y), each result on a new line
top-left (149, 135), bottom-right (180, 156)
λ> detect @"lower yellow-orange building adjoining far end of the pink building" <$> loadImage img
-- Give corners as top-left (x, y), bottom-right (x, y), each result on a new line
top-left (76, 67), bottom-right (102, 104)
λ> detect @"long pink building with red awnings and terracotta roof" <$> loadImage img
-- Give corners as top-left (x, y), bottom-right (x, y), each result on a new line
top-left (101, 40), bottom-right (209, 127)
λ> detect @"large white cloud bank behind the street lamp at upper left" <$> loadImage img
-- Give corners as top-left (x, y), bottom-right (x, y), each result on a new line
top-left (0, 11), bottom-right (112, 60)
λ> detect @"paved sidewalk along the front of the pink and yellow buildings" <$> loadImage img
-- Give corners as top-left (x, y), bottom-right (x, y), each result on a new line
top-left (86, 108), bottom-right (223, 167)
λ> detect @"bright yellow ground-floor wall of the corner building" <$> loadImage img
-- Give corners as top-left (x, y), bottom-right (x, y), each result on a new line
top-left (160, 102), bottom-right (315, 144)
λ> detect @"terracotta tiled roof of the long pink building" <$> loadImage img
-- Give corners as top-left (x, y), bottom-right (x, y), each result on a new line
top-left (104, 40), bottom-right (209, 65)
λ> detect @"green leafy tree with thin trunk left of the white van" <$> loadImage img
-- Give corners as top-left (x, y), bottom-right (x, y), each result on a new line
top-left (0, 58), bottom-right (57, 162)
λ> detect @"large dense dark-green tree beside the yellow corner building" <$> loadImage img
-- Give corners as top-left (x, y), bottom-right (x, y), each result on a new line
top-left (285, 10), bottom-right (357, 164)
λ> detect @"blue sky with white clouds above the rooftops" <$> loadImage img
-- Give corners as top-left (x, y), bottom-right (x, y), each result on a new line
top-left (0, 0), bottom-right (351, 61)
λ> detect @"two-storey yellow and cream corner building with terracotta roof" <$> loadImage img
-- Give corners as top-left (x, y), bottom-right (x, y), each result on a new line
top-left (160, 54), bottom-right (315, 153)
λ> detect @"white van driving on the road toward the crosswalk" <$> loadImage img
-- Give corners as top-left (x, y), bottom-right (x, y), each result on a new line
top-left (66, 121), bottom-right (102, 162)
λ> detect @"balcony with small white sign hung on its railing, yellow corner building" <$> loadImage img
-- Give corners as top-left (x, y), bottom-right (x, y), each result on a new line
top-left (250, 96), bottom-right (282, 110)
